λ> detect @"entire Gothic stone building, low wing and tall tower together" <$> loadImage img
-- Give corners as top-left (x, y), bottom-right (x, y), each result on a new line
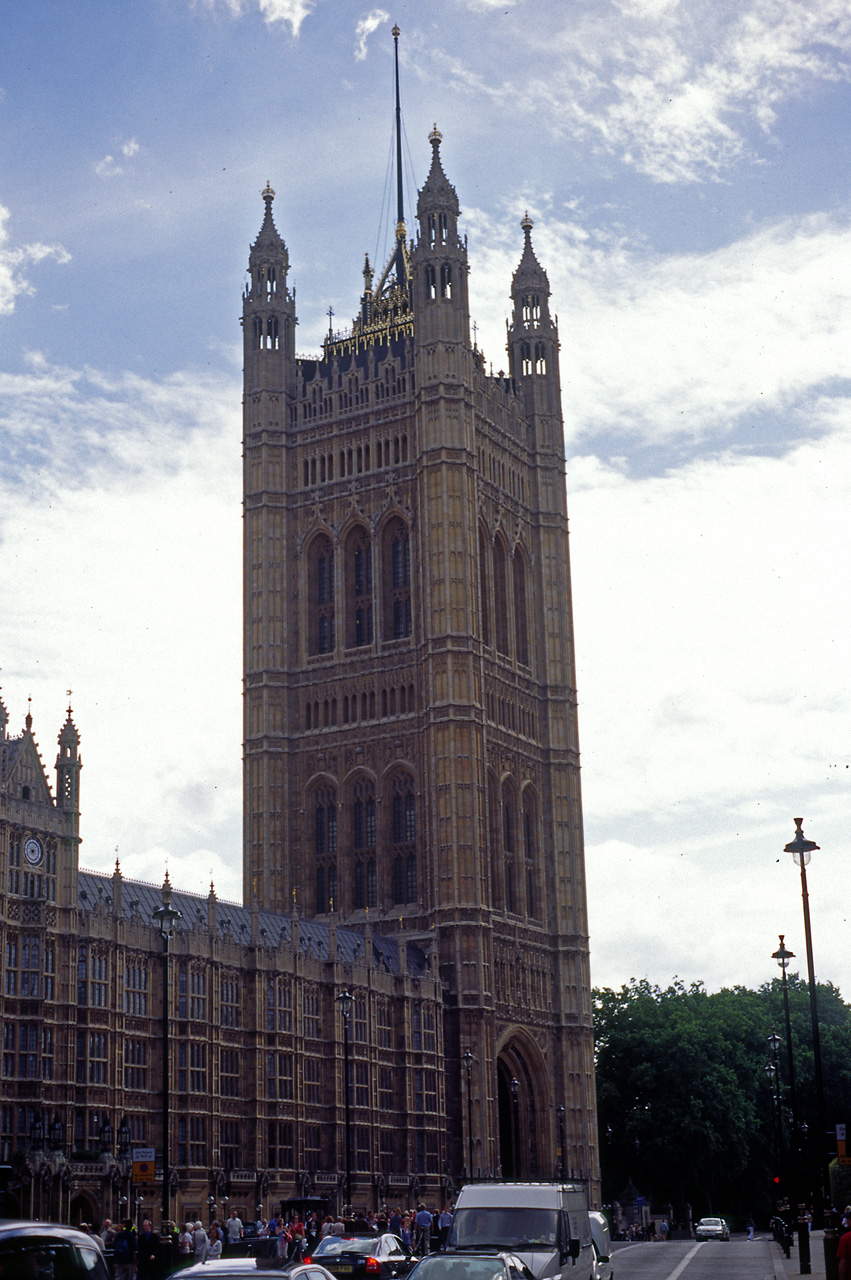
top-left (0, 122), bottom-right (599, 1222)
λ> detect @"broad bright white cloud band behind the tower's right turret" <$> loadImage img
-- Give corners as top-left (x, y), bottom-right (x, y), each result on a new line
top-left (467, 206), bottom-right (851, 445)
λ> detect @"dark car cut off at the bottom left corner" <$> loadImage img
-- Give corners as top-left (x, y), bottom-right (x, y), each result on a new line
top-left (0, 1222), bottom-right (109, 1280)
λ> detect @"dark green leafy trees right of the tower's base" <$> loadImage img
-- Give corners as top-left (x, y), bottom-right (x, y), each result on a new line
top-left (593, 975), bottom-right (851, 1221)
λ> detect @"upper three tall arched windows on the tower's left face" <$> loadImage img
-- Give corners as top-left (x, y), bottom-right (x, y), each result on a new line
top-left (307, 517), bottom-right (412, 654)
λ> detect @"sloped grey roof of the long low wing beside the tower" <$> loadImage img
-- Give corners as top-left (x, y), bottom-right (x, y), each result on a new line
top-left (78, 870), bottom-right (427, 977)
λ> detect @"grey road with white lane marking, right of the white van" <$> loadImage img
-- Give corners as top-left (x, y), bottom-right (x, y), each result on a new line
top-left (612, 1234), bottom-right (777, 1280)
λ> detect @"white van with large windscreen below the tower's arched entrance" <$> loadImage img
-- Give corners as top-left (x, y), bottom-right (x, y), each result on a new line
top-left (447, 1183), bottom-right (594, 1280)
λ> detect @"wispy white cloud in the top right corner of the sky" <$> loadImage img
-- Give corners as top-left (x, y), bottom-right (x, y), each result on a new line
top-left (438, 0), bottom-right (851, 183)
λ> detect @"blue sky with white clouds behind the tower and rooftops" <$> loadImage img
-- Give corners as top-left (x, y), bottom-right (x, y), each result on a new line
top-left (0, 0), bottom-right (851, 1000)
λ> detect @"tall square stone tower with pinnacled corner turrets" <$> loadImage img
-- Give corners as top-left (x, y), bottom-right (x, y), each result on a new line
top-left (243, 128), bottom-right (599, 1189)
